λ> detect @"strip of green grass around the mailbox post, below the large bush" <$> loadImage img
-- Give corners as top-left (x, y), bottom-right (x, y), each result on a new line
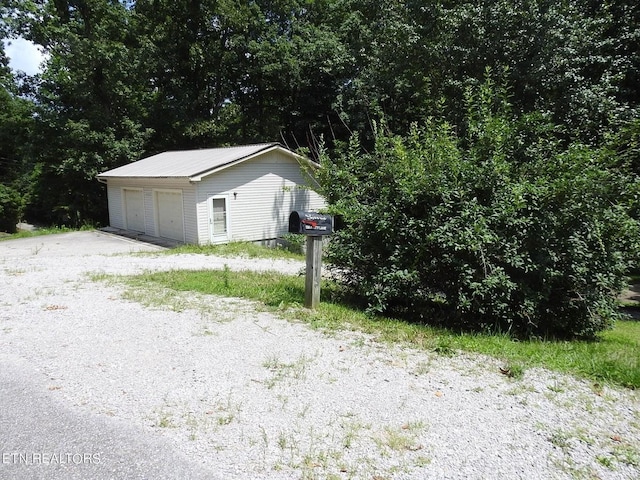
top-left (121, 268), bottom-right (640, 389)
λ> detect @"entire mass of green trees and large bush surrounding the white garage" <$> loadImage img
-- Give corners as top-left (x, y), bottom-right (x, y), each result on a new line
top-left (0, 0), bottom-right (640, 335)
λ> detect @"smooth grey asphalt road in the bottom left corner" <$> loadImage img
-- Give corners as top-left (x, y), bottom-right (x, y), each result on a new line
top-left (0, 356), bottom-right (219, 480)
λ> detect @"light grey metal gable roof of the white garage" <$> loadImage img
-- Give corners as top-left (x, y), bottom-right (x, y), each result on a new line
top-left (98, 143), bottom-right (315, 181)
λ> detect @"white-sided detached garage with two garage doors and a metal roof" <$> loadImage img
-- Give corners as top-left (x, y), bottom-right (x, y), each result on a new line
top-left (98, 143), bottom-right (325, 244)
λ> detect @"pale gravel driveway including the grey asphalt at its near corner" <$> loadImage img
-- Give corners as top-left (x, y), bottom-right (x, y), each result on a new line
top-left (0, 232), bottom-right (640, 479)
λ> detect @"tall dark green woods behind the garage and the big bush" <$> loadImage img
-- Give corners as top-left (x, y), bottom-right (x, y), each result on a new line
top-left (0, 0), bottom-right (640, 225)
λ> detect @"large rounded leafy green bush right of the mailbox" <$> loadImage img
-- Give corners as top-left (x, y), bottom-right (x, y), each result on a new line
top-left (319, 82), bottom-right (638, 337)
